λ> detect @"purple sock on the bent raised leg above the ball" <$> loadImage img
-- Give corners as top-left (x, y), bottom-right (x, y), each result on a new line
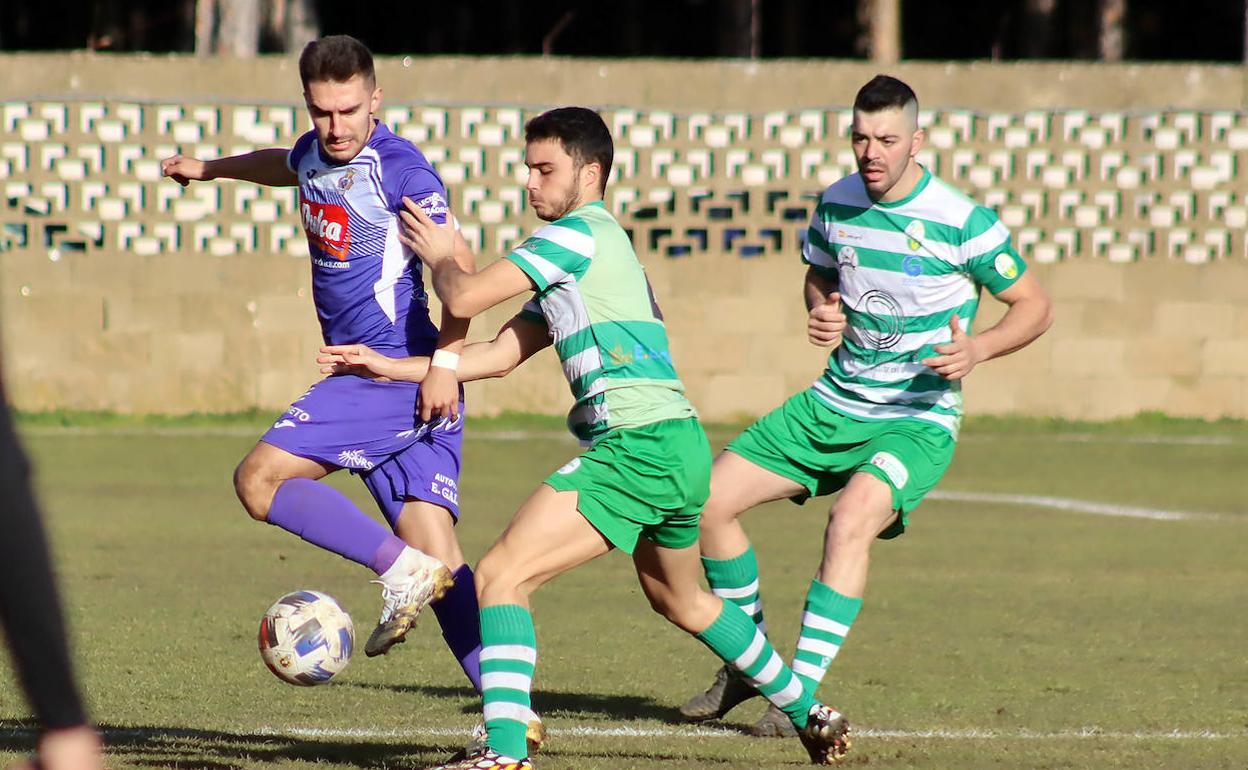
top-left (268, 478), bottom-right (404, 574)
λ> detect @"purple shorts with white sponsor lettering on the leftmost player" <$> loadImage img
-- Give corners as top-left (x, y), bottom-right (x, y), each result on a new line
top-left (260, 374), bottom-right (464, 527)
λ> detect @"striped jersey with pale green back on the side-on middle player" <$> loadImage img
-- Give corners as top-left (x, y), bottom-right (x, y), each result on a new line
top-left (505, 201), bottom-right (698, 443)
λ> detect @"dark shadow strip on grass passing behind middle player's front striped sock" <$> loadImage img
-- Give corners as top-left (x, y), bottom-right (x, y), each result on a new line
top-left (342, 681), bottom-right (681, 723)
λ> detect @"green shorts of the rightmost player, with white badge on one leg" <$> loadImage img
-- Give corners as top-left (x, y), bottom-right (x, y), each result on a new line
top-left (728, 389), bottom-right (955, 538)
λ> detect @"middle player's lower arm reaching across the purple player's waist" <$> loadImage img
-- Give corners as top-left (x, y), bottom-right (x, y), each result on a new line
top-left (316, 316), bottom-right (550, 382)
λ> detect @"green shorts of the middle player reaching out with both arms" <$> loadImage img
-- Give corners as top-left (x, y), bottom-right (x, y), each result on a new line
top-left (545, 418), bottom-right (711, 554)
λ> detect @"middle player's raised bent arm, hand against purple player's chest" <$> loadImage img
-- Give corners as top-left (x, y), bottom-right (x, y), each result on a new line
top-left (398, 197), bottom-right (534, 319)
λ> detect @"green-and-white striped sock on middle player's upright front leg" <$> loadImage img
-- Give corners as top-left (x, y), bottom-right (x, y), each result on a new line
top-left (480, 604), bottom-right (538, 759)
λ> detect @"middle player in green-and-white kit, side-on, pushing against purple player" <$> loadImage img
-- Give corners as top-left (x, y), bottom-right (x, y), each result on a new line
top-left (321, 107), bottom-right (849, 770)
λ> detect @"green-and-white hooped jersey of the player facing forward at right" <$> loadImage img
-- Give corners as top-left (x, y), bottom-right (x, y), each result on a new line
top-left (801, 168), bottom-right (1027, 437)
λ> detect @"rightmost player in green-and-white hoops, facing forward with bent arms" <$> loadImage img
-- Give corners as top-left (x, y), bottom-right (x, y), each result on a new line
top-left (681, 75), bottom-right (1052, 735)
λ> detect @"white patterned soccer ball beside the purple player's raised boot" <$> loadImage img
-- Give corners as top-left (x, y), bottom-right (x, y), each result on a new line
top-left (260, 590), bottom-right (356, 686)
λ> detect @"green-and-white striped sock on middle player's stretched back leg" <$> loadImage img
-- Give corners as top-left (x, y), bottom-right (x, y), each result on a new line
top-left (695, 602), bottom-right (815, 729)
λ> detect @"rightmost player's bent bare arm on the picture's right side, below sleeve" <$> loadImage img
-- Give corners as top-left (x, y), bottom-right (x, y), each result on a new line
top-left (924, 272), bottom-right (1053, 379)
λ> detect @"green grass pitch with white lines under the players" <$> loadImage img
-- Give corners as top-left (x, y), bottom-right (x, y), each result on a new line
top-left (0, 418), bottom-right (1248, 770)
